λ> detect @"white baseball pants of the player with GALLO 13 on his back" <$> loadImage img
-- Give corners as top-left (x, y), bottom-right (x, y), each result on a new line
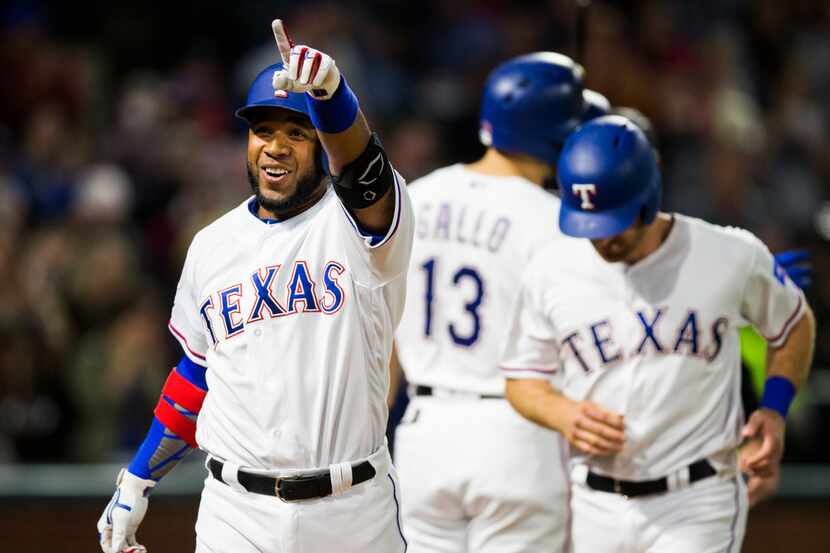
top-left (395, 397), bottom-right (568, 553)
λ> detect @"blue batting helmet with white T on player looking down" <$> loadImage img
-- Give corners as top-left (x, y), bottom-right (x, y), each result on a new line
top-left (558, 115), bottom-right (661, 239)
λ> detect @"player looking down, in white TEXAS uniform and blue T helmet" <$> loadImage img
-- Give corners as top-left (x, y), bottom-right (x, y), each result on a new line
top-left (502, 116), bottom-right (814, 553)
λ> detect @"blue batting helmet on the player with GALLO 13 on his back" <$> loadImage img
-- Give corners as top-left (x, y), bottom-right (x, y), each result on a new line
top-left (479, 52), bottom-right (607, 164)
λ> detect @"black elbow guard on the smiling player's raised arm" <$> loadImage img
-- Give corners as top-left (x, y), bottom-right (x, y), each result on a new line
top-left (331, 133), bottom-right (395, 209)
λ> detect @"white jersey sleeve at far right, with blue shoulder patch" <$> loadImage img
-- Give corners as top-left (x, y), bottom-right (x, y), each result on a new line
top-left (741, 232), bottom-right (806, 347)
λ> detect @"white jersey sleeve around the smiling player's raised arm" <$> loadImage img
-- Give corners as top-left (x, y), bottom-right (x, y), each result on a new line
top-left (340, 170), bottom-right (414, 285)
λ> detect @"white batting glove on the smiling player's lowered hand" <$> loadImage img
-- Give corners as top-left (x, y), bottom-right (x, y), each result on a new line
top-left (98, 469), bottom-right (156, 553)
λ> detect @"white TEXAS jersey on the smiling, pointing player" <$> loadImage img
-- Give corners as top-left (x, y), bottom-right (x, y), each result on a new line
top-left (170, 174), bottom-right (413, 469)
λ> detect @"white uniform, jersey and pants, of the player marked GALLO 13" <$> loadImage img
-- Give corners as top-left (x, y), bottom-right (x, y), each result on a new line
top-left (395, 165), bottom-right (568, 553)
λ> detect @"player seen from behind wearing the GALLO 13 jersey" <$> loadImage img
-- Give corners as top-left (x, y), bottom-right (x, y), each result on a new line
top-left (395, 52), bottom-right (608, 553)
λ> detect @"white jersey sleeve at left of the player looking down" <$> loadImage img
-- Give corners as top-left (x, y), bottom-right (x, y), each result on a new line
top-left (500, 264), bottom-right (560, 380)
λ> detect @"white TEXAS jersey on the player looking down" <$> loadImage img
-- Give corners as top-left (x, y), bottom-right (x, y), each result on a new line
top-left (502, 215), bottom-right (806, 480)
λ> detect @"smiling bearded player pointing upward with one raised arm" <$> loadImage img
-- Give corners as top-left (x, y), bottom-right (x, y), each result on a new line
top-left (98, 20), bottom-right (413, 553)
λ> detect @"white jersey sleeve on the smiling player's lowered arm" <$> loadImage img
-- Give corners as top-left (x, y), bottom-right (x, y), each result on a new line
top-left (167, 239), bottom-right (208, 367)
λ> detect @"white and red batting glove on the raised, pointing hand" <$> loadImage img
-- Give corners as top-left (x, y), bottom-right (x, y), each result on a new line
top-left (271, 19), bottom-right (340, 100)
